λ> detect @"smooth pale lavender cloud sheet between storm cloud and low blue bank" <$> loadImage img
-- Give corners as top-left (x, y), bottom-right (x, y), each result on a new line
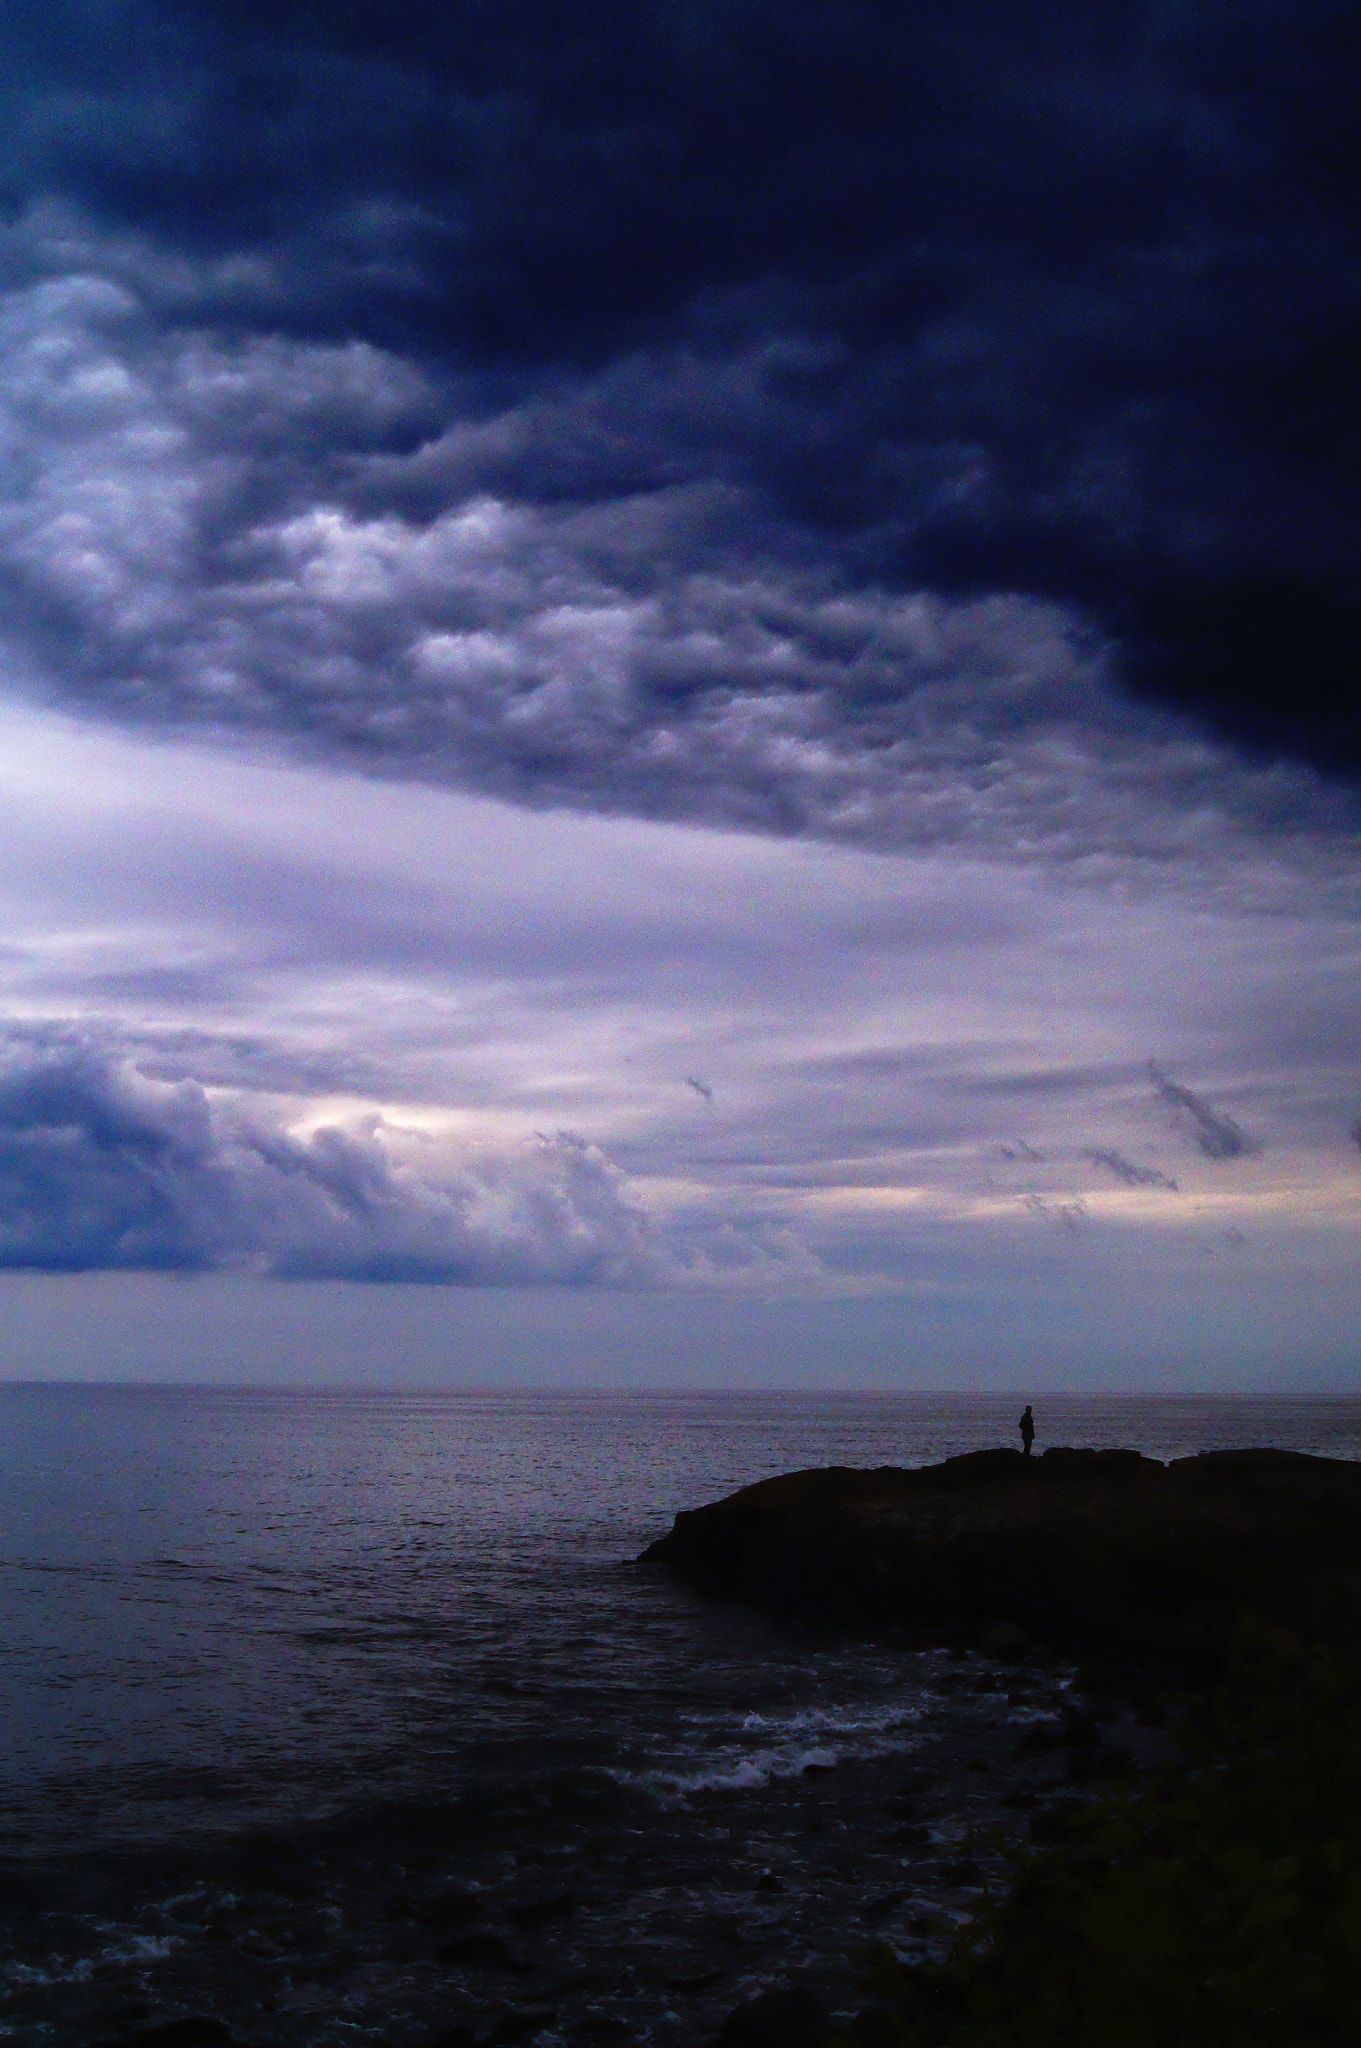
top-left (0, 696), bottom-right (1357, 1310)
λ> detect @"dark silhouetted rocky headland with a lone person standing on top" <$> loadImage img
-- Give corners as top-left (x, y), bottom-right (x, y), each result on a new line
top-left (641, 1450), bottom-right (1361, 1665)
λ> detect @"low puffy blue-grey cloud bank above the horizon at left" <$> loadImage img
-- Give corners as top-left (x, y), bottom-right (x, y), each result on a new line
top-left (0, 1034), bottom-right (661, 1286)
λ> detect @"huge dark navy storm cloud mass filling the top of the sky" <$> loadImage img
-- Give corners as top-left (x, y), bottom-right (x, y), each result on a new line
top-left (0, 0), bottom-right (1361, 831)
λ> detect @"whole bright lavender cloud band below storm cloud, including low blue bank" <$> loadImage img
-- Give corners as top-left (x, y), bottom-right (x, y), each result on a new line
top-left (0, 713), bottom-right (1361, 1294)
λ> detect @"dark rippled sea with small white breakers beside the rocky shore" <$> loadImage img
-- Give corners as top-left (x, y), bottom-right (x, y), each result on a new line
top-left (0, 1384), bottom-right (1361, 2048)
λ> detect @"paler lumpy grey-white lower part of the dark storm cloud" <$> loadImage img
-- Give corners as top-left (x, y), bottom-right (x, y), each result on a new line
top-left (0, 262), bottom-right (1351, 887)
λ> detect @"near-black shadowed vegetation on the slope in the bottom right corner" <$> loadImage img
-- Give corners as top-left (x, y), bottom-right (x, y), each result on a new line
top-left (851, 1647), bottom-right (1361, 2048)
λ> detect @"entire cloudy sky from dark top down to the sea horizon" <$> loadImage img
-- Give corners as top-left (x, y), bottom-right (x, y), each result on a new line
top-left (0, 0), bottom-right (1361, 1395)
